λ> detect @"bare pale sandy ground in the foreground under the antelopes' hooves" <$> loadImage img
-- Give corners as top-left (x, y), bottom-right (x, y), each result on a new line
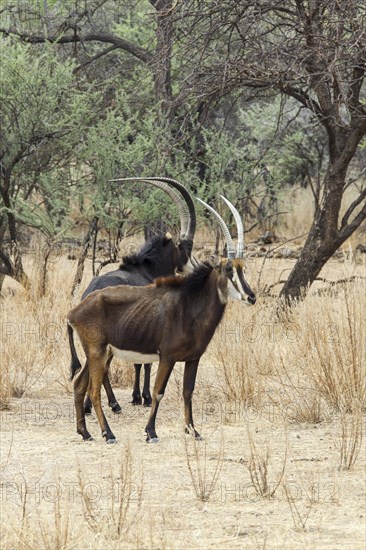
top-left (1, 374), bottom-right (366, 550)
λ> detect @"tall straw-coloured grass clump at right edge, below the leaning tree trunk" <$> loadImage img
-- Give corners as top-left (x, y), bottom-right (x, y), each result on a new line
top-left (297, 283), bottom-right (366, 412)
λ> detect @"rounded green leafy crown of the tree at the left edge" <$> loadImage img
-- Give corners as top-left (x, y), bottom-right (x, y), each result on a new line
top-left (0, 39), bottom-right (90, 165)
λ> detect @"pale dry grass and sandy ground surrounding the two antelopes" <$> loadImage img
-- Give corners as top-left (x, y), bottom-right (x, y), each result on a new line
top-left (0, 248), bottom-right (366, 550)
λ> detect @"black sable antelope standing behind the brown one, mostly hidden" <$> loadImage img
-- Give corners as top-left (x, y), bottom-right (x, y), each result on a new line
top-left (82, 177), bottom-right (196, 414)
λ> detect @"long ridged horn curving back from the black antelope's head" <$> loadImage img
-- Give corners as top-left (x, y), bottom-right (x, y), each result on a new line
top-left (110, 177), bottom-right (196, 241)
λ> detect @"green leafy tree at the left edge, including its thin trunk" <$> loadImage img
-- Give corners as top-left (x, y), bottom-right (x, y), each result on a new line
top-left (0, 38), bottom-right (93, 286)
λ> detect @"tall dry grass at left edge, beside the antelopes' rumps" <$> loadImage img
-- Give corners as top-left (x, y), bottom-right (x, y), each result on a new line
top-left (1, 262), bottom-right (71, 398)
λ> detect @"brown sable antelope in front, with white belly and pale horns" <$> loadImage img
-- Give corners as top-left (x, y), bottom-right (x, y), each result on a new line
top-left (68, 199), bottom-right (255, 443)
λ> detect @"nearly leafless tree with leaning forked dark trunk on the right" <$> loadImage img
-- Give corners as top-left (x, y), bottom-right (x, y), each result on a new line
top-left (175, 0), bottom-right (366, 301)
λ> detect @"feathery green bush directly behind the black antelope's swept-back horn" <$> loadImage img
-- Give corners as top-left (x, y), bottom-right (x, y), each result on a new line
top-left (80, 97), bottom-right (189, 235)
